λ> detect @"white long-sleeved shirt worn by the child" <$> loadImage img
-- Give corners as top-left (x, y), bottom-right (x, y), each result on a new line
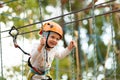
top-left (31, 44), bottom-right (70, 71)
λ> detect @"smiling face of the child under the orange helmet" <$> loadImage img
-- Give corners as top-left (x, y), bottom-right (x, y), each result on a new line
top-left (47, 32), bottom-right (60, 47)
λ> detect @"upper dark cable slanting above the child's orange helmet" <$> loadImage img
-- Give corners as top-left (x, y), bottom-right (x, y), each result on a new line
top-left (1, 0), bottom-right (116, 33)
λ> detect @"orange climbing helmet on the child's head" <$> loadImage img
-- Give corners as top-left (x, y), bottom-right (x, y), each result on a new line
top-left (39, 22), bottom-right (63, 38)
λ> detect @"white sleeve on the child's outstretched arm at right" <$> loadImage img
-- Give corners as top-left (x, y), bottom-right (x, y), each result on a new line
top-left (55, 47), bottom-right (71, 59)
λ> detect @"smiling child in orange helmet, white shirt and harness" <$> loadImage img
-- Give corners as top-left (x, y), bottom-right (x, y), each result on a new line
top-left (28, 22), bottom-right (75, 80)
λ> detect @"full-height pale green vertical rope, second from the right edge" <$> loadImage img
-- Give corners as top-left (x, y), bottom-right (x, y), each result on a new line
top-left (92, 0), bottom-right (97, 79)
